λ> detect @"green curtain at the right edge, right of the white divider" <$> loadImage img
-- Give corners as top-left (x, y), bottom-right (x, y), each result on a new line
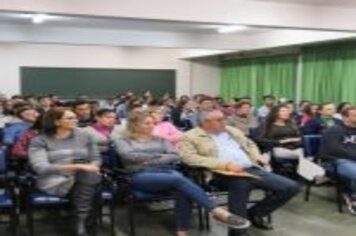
top-left (302, 43), bottom-right (356, 103)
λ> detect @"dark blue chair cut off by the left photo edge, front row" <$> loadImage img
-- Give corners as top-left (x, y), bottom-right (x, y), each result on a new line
top-left (0, 146), bottom-right (19, 236)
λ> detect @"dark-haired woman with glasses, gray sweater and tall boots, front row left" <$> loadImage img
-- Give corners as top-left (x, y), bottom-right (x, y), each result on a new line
top-left (29, 108), bottom-right (101, 236)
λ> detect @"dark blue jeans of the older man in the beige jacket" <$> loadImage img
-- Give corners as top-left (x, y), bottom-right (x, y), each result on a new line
top-left (214, 167), bottom-right (300, 235)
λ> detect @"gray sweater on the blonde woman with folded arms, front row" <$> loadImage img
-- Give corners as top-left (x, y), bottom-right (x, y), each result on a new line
top-left (114, 137), bottom-right (180, 171)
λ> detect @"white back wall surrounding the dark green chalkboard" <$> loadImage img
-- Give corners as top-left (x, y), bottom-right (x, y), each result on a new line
top-left (0, 43), bottom-right (218, 95)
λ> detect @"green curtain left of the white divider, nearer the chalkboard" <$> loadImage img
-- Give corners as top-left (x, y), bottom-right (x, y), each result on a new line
top-left (220, 55), bottom-right (297, 105)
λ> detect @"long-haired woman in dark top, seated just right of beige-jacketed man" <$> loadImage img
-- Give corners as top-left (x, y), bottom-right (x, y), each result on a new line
top-left (259, 105), bottom-right (302, 159)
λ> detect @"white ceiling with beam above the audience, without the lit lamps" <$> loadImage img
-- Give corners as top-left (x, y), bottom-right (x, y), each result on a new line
top-left (0, 0), bottom-right (356, 51)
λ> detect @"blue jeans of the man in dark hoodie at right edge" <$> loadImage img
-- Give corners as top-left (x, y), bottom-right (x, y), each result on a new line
top-left (325, 159), bottom-right (356, 197)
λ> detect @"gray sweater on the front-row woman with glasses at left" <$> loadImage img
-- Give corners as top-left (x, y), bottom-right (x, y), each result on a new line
top-left (29, 129), bottom-right (101, 196)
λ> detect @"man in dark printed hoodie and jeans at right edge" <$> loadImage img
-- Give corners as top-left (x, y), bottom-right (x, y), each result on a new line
top-left (320, 106), bottom-right (356, 215)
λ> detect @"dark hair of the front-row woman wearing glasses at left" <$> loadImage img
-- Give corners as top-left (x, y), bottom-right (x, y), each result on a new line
top-left (41, 107), bottom-right (71, 136)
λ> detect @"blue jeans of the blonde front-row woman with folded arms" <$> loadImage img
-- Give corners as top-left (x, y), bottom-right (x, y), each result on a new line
top-left (132, 168), bottom-right (217, 231)
